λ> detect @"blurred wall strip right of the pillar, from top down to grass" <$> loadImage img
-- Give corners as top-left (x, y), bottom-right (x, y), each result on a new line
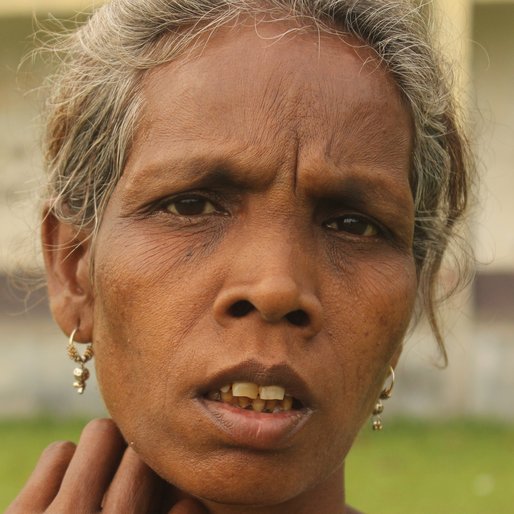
top-left (470, 3), bottom-right (514, 415)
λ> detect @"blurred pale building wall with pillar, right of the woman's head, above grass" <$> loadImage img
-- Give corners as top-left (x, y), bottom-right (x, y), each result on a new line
top-left (388, 0), bottom-right (514, 419)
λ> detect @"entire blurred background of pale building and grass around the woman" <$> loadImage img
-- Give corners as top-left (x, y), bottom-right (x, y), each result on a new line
top-left (0, 0), bottom-right (514, 514)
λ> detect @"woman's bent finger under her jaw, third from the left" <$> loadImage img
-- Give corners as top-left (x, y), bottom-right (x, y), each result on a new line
top-left (102, 448), bottom-right (163, 514)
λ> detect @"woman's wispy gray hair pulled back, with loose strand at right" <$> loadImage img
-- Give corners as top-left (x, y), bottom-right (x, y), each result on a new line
top-left (40, 0), bottom-right (473, 361)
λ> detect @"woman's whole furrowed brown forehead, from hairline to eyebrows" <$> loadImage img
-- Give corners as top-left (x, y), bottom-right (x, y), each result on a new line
top-left (125, 22), bottom-right (412, 194)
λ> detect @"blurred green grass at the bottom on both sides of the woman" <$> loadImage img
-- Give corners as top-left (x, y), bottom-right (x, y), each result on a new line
top-left (0, 419), bottom-right (514, 514)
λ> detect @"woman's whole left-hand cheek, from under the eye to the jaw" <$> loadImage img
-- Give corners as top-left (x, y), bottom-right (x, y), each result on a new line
top-left (90, 227), bottom-right (210, 437)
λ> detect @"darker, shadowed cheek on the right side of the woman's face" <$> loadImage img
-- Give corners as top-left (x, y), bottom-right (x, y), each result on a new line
top-left (323, 252), bottom-right (417, 420)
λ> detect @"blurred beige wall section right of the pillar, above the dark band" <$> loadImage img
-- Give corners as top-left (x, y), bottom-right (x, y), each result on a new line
top-left (472, 4), bottom-right (514, 270)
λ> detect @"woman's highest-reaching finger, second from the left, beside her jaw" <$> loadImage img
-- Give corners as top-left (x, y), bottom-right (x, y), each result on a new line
top-left (52, 419), bottom-right (126, 514)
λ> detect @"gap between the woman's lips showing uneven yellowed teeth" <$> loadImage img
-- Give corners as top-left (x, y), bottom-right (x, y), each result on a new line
top-left (205, 382), bottom-right (304, 414)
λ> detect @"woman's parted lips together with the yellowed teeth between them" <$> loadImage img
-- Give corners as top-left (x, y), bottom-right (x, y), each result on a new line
top-left (198, 359), bottom-right (312, 450)
